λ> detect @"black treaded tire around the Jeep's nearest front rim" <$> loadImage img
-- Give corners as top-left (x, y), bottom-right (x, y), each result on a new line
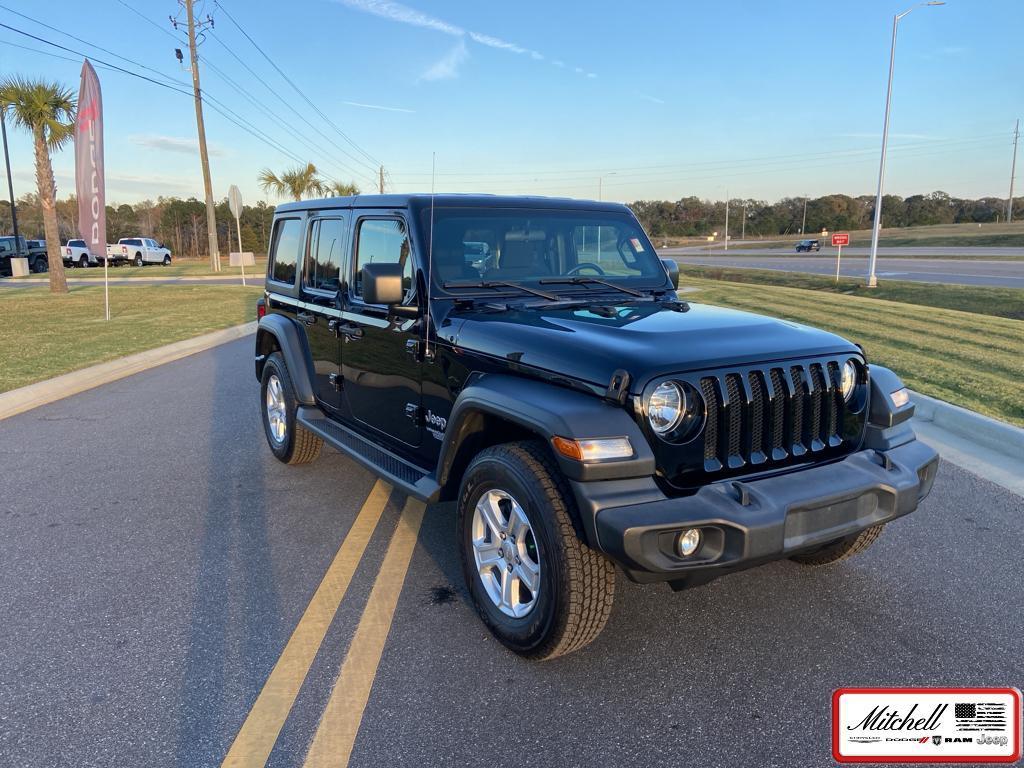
top-left (456, 440), bottom-right (615, 659)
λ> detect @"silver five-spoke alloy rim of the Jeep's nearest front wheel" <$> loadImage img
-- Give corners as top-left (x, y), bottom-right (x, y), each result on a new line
top-left (471, 488), bottom-right (541, 618)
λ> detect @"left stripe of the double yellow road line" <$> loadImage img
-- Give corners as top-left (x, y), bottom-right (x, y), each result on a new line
top-left (223, 480), bottom-right (391, 767)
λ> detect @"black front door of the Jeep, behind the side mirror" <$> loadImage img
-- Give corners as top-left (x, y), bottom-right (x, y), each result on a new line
top-left (340, 213), bottom-right (423, 447)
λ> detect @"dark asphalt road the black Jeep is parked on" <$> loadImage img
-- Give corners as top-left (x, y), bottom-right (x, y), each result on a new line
top-left (0, 340), bottom-right (1024, 768)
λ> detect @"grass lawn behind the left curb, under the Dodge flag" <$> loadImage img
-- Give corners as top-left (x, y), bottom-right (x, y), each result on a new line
top-left (0, 286), bottom-right (263, 392)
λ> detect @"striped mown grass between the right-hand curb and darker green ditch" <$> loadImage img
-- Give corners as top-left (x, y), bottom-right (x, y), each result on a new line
top-left (683, 274), bottom-right (1024, 426)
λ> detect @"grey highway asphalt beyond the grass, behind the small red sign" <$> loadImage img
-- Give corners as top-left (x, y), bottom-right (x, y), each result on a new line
top-left (658, 248), bottom-right (1024, 288)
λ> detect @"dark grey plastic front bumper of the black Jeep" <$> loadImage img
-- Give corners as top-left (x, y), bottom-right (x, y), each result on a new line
top-left (593, 440), bottom-right (939, 589)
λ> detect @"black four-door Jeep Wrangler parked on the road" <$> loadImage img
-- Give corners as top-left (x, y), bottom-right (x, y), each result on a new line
top-left (256, 195), bottom-right (938, 658)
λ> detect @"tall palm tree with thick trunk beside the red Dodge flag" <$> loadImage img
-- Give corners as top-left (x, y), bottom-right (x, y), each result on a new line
top-left (0, 76), bottom-right (76, 293)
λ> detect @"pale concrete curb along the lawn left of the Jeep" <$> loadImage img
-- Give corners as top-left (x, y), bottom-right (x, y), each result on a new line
top-left (0, 321), bottom-right (256, 420)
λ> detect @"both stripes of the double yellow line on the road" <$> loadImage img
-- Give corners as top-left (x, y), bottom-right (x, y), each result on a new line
top-left (222, 480), bottom-right (425, 768)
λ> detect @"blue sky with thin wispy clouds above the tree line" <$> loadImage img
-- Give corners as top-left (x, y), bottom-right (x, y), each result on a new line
top-left (0, 0), bottom-right (1024, 202)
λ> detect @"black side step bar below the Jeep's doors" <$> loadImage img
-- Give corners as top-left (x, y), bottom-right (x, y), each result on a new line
top-left (296, 406), bottom-right (440, 504)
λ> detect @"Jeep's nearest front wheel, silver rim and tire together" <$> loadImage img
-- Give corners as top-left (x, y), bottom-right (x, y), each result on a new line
top-left (457, 441), bottom-right (615, 659)
